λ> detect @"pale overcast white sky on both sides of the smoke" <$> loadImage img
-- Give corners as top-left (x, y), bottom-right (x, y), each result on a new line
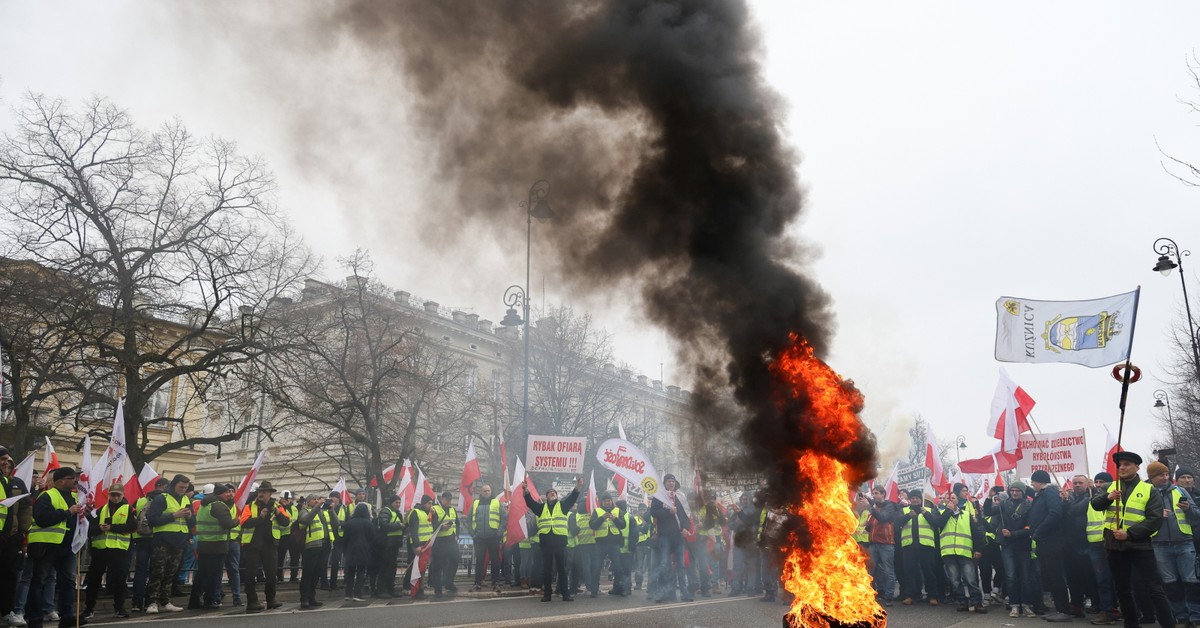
top-left (0, 1), bottom-right (1200, 473)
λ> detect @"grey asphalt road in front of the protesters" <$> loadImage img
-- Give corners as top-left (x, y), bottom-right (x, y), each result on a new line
top-left (84, 594), bottom-right (1091, 628)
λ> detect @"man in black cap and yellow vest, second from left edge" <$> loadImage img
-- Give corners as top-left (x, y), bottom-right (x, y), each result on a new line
top-left (25, 467), bottom-right (84, 628)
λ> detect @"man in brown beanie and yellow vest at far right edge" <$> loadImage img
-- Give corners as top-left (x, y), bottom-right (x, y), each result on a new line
top-left (1146, 460), bottom-right (1200, 624)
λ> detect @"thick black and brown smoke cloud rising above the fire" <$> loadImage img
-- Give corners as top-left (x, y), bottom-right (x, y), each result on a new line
top-left (314, 0), bottom-right (875, 500)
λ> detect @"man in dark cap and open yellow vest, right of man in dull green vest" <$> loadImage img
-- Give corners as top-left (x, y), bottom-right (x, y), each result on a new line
top-left (239, 482), bottom-right (292, 612)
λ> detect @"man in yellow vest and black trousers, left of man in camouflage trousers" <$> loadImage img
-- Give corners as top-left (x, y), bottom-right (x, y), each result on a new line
top-left (83, 484), bottom-right (138, 620)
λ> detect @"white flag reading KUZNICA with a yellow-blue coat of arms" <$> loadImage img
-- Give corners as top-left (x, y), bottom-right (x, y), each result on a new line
top-left (996, 288), bottom-right (1140, 367)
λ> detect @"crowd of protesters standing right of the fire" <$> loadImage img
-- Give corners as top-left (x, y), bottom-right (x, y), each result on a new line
top-left (854, 451), bottom-right (1200, 628)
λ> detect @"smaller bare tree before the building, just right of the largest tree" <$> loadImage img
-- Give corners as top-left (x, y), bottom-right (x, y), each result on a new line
top-left (253, 252), bottom-right (479, 499)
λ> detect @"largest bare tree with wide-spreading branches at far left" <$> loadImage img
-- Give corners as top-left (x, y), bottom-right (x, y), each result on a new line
top-left (0, 95), bottom-right (313, 465)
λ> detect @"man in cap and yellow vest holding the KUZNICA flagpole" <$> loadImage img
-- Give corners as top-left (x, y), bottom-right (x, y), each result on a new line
top-left (1092, 451), bottom-right (1175, 628)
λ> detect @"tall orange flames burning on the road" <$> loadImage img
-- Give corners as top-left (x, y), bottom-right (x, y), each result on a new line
top-left (772, 336), bottom-right (884, 628)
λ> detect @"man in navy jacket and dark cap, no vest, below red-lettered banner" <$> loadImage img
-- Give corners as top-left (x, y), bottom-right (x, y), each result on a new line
top-left (1026, 468), bottom-right (1072, 622)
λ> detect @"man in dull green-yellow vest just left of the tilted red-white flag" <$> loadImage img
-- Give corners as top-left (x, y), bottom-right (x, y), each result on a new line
top-left (187, 484), bottom-right (238, 610)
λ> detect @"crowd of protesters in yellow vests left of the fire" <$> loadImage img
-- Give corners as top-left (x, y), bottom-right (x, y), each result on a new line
top-left (0, 448), bottom-right (787, 628)
